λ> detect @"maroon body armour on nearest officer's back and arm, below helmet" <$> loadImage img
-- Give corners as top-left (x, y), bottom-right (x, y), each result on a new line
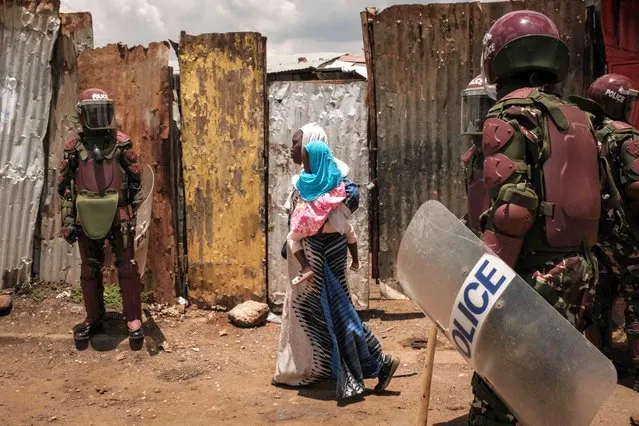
top-left (482, 88), bottom-right (601, 266)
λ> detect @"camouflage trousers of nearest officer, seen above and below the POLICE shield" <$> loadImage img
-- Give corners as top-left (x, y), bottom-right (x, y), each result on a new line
top-left (468, 255), bottom-right (597, 426)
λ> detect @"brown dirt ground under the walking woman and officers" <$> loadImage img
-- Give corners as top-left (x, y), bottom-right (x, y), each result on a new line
top-left (0, 289), bottom-right (639, 425)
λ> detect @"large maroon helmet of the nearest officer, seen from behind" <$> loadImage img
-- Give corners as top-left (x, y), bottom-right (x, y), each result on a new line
top-left (481, 10), bottom-right (569, 84)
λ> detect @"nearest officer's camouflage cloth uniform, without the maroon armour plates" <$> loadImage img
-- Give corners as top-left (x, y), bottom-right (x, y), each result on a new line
top-left (470, 89), bottom-right (599, 425)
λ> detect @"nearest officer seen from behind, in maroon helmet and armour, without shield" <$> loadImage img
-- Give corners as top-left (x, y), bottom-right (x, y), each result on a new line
top-left (469, 10), bottom-right (601, 425)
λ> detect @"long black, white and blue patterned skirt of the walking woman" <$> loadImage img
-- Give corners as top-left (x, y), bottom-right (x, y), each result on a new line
top-left (274, 234), bottom-right (382, 400)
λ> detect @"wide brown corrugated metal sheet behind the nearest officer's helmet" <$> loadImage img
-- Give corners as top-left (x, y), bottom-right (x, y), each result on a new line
top-left (364, 0), bottom-right (586, 297)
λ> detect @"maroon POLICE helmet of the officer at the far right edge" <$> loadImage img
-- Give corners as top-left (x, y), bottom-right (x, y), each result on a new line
top-left (587, 74), bottom-right (639, 121)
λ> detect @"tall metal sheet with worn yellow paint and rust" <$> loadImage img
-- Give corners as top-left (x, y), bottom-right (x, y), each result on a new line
top-left (179, 33), bottom-right (267, 306)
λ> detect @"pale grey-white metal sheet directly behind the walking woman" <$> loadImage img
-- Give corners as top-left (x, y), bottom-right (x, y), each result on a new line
top-left (268, 81), bottom-right (370, 309)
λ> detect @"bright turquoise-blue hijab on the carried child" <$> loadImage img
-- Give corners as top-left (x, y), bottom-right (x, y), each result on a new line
top-left (297, 140), bottom-right (342, 202)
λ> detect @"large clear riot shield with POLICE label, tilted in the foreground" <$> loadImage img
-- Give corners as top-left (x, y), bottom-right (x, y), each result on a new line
top-left (397, 200), bottom-right (617, 425)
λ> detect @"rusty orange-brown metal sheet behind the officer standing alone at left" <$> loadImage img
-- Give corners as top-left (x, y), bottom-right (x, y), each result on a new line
top-left (78, 42), bottom-right (177, 302)
